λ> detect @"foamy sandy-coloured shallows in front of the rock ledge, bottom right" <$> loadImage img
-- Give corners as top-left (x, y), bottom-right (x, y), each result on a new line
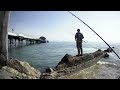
top-left (58, 58), bottom-right (120, 79)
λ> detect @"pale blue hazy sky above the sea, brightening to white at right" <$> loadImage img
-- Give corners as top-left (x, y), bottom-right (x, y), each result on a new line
top-left (8, 11), bottom-right (120, 42)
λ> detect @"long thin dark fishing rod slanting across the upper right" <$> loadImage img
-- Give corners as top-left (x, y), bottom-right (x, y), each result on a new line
top-left (68, 11), bottom-right (120, 59)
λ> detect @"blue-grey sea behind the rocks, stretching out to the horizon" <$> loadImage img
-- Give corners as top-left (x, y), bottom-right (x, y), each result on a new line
top-left (9, 42), bottom-right (120, 71)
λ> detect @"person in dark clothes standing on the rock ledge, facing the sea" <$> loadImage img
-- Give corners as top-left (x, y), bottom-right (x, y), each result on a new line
top-left (75, 29), bottom-right (84, 56)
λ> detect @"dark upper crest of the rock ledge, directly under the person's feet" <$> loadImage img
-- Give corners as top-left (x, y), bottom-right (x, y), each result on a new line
top-left (55, 50), bottom-right (104, 70)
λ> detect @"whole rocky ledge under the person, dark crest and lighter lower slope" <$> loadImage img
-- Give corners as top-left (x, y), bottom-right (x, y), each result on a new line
top-left (41, 50), bottom-right (108, 79)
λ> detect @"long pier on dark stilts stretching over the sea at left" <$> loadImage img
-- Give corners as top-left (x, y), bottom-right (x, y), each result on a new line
top-left (8, 32), bottom-right (43, 47)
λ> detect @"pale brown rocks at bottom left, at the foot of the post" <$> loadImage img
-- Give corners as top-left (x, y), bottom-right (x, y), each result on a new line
top-left (0, 59), bottom-right (41, 79)
